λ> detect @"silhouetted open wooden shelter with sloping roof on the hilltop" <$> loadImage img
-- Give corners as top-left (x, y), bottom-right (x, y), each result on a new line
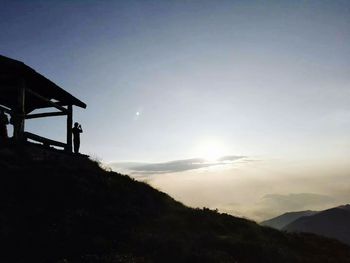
top-left (0, 55), bottom-right (86, 152)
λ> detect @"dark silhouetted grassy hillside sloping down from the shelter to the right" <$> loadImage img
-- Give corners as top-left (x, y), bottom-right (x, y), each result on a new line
top-left (0, 146), bottom-right (350, 263)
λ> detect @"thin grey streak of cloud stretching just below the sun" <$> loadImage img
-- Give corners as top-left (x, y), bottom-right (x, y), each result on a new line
top-left (109, 155), bottom-right (245, 174)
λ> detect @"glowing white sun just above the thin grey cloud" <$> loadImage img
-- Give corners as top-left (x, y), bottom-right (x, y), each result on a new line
top-left (195, 138), bottom-right (228, 162)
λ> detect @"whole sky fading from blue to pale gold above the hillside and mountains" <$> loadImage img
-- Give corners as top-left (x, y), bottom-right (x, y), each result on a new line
top-left (0, 0), bottom-right (350, 220)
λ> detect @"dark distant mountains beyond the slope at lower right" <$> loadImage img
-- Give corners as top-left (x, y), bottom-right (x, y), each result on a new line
top-left (283, 205), bottom-right (350, 245)
